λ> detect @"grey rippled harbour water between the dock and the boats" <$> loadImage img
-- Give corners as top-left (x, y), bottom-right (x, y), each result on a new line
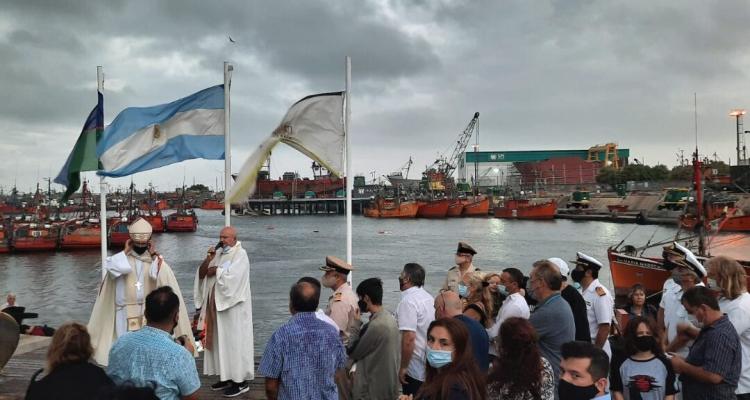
top-left (0, 210), bottom-right (675, 352)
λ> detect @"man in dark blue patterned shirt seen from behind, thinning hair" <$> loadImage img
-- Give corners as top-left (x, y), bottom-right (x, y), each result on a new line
top-left (258, 278), bottom-right (346, 400)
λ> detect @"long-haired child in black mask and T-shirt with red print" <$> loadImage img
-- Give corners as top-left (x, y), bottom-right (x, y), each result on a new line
top-left (610, 317), bottom-right (676, 400)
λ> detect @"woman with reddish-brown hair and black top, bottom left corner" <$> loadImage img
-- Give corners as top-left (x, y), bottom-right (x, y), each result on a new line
top-left (26, 322), bottom-right (112, 400)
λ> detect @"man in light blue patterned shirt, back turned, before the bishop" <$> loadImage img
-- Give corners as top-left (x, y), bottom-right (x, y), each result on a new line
top-left (107, 286), bottom-right (201, 400)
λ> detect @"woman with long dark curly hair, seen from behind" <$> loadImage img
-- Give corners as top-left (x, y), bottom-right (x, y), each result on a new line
top-left (487, 317), bottom-right (555, 400)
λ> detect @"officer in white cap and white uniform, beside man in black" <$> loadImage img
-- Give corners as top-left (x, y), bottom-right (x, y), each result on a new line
top-left (570, 252), bottom-right (615, 357)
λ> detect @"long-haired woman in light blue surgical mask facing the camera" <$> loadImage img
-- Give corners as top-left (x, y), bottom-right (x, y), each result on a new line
top-left (399, 318), bottom-right (487, 400)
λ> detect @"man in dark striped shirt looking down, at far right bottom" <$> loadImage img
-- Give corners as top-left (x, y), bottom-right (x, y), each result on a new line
top-left (672, 286), bottom-right (742, 400)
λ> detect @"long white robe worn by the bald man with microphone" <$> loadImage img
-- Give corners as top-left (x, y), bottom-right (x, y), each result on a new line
top-left (194, 242), bottom-right (255, 382)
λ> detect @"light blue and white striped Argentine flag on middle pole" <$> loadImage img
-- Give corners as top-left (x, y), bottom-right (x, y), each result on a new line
top-left (96, 85), bottom-right (224, 177)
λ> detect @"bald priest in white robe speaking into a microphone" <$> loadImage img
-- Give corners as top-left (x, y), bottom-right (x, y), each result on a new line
top-left (194, 227), bottom-right (255, 396)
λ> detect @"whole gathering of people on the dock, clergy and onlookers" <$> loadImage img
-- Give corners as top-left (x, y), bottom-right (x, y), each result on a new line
top-left (13, 219), bottom-right (750, 400)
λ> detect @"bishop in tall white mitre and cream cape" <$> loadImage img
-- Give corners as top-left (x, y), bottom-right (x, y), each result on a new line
top-left (88, 218), bottom-right (195, 365)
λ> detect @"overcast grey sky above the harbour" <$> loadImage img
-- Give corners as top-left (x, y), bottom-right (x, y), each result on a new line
top-left (0, 0), bottom-right (750, 191)
